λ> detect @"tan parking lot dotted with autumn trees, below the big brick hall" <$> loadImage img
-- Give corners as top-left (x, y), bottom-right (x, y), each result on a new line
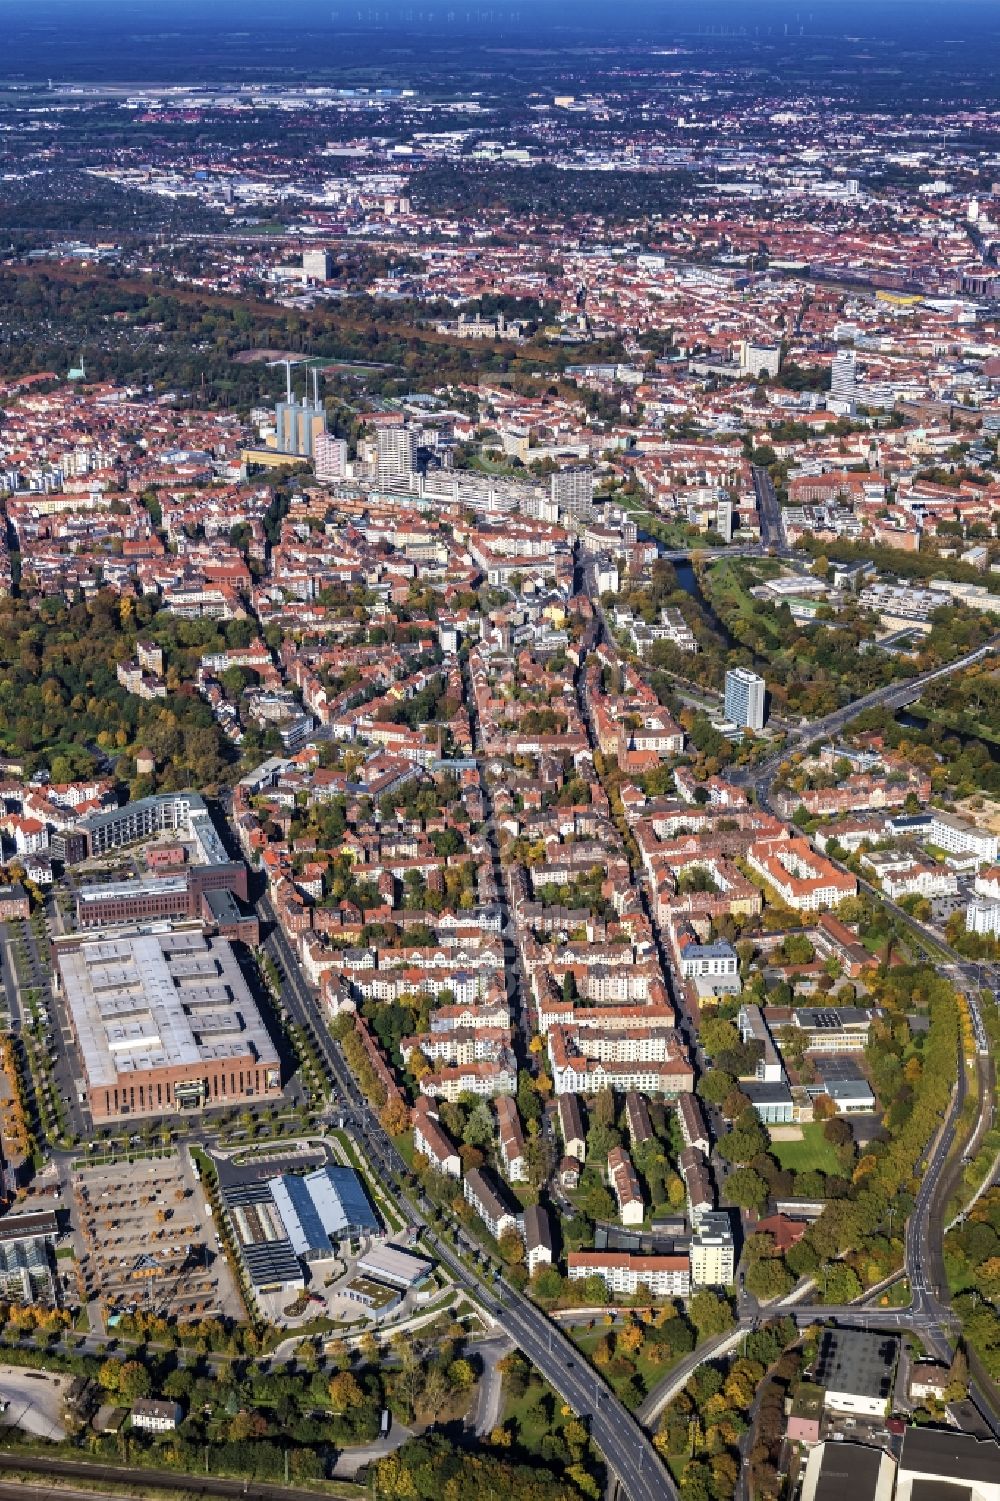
top-left (74, 1151), bottom-right (243, 1321)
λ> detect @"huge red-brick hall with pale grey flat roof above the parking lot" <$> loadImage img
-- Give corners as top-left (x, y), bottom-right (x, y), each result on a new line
top-left (54, 925), bottom-right (281, 1118)
